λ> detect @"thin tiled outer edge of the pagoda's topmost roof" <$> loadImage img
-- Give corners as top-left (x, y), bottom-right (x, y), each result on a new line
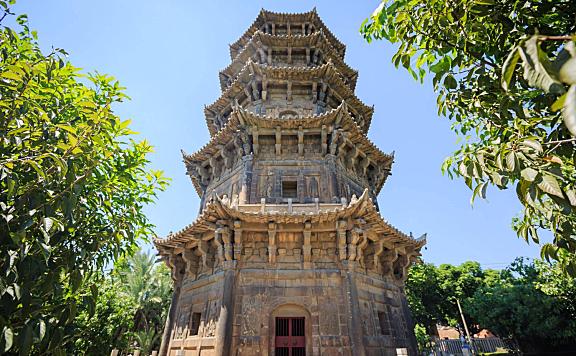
top-left (229, 7), bottom-right (346, 59)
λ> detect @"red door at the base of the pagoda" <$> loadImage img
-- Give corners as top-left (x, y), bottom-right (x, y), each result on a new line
top-left (274, 317), bottom-right (306, 356)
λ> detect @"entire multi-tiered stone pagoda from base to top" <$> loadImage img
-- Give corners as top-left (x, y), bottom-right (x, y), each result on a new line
top-left (155, 10), bottom-right (426, 356)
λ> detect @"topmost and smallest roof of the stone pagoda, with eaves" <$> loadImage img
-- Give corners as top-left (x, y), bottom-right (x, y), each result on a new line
top-left (230, 8), bottom-right (346, 59)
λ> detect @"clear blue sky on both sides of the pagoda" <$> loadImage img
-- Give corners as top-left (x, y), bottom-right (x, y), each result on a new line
top-left (14, 0), bottom-right (538, 268)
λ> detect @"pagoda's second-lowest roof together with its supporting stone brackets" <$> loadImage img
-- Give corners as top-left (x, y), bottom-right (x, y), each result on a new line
top-left (183, 102), bottom-right (394, 196)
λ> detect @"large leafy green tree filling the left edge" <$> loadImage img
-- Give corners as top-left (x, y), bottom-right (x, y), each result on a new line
top-left (0, 6), bottom-right (166, 355)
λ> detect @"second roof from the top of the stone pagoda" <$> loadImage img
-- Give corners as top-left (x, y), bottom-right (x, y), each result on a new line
top-left (220, 29), bottom-right (358, 91)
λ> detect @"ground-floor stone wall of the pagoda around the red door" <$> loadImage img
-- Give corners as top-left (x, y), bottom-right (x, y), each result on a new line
top-left (169, 261), bottom-right (412, 356)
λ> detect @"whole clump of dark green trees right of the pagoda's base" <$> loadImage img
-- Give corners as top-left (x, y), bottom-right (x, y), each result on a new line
top-left (406, 258), bottom-right (576, 352)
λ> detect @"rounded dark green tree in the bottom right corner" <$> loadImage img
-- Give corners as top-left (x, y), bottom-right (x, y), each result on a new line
top-left (464, 259), bottom-right (576, 353)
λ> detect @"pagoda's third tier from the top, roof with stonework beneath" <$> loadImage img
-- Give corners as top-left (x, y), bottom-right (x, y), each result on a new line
top-left (204, 59), bottom-right (374, 136)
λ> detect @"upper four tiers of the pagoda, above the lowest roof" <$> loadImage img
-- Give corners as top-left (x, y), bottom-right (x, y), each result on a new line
top-left (183, 9), bottom-right (394, 208)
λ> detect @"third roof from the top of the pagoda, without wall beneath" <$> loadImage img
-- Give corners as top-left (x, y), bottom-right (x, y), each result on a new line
top-left (204, 59), bottom-right (374, 136)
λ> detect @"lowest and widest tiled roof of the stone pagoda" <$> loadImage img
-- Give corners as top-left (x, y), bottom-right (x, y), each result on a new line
top-left (154, 189), bottom-right (426, 249)
